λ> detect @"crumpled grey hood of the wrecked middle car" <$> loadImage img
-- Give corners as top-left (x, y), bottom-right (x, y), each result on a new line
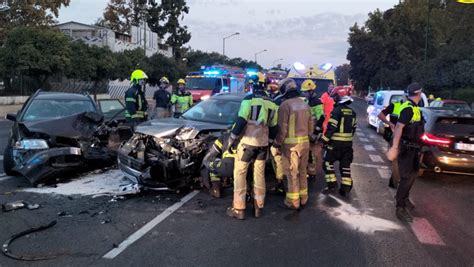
top-left (135, 118), bottom-right (228, 139)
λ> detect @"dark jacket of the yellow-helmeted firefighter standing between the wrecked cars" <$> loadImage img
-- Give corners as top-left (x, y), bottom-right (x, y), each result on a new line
top-left (125, 85), bottom-right (148, 120)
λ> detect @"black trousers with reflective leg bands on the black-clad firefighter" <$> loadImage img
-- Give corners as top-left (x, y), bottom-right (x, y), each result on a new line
top-left (323, 147), bottom-right (354, 193)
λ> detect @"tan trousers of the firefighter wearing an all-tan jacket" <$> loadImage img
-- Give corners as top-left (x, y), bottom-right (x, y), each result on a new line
top-left (282, 142), bottom-right (309, 209)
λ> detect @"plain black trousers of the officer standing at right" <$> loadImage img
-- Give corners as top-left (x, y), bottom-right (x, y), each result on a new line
top-left (395, 148), bottom-right (420, 207)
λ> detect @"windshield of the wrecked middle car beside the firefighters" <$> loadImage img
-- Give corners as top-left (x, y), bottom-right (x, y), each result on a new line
top-left (183, 99), bottom-right (240, 125)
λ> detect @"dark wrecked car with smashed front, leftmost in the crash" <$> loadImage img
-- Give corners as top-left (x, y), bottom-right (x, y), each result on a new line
top-left (3, 91), bottom-right (132, 185)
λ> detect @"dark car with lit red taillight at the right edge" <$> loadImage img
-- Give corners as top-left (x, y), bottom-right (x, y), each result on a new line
top-left (419, 108), bottom-right (474, 175)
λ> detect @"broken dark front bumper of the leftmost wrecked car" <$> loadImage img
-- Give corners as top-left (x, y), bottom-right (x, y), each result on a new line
top-left (14, 147), bottom-right (82, 184)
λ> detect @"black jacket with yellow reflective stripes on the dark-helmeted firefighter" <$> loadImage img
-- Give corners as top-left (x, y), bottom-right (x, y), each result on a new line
top-left (322, 104), bottom-right (357, 146)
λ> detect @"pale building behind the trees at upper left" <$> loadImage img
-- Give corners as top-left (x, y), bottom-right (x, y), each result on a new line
top-left (55, 21), bottom-right (173, 57)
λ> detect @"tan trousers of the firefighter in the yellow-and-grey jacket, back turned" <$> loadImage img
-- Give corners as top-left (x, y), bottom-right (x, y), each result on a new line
top-left (233, 142), bottom-right (268, 210)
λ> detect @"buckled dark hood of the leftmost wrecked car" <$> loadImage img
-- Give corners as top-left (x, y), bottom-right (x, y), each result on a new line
top-left (21, 112), bottom-right (103, 139)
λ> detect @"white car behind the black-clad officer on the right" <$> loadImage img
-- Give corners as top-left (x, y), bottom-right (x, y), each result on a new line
top-left (367, 90), bottom-right (428, 134)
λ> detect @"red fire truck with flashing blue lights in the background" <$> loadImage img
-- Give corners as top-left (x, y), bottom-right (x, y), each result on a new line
top-left (186, 65), bottom-right (246, 102)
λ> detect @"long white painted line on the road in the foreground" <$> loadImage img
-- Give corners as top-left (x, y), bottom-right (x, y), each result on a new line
top-left (103, 191), bottom-right (199, 259)
